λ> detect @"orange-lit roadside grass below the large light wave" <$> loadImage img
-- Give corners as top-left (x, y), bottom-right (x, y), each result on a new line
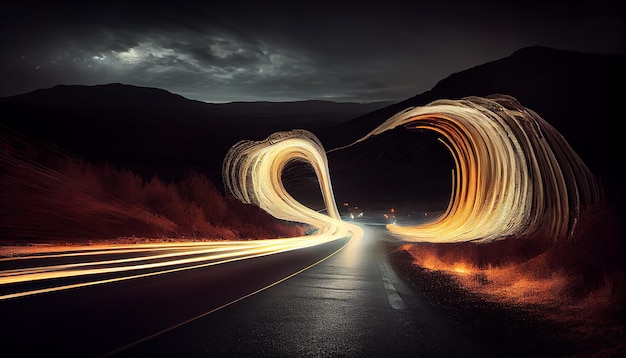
top-left (391, 203), bottom-right (626, 357)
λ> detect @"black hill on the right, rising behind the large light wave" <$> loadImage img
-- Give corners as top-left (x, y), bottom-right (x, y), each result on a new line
top-left (319, 47), bottom-right (626, 211)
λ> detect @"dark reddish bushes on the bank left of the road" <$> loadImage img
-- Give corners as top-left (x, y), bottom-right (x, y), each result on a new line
top-left (0, 133), bottom-right (304, 244)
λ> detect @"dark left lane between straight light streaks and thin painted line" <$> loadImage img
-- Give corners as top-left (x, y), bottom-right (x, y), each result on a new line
top-left (0, 236), bottom-right (347, 358)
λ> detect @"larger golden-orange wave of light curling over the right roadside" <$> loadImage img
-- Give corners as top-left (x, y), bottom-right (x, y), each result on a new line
top-left (332, 95), bottom-right (600, 242)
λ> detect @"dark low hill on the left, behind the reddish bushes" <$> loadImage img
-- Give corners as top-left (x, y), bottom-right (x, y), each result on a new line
top-left (0, 83), bottom-right (390, 186)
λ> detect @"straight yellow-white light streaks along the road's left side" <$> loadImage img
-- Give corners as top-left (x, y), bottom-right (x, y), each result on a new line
top-left (0, 236), bottom-right (346, 301)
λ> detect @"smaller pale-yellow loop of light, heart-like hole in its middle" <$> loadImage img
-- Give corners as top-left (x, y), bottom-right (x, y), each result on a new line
top-left (222, 130), bottom-right (363, 239)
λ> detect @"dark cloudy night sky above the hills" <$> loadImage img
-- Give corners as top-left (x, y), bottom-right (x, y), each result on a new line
top-left (0, 1), bottom-right (626, 102)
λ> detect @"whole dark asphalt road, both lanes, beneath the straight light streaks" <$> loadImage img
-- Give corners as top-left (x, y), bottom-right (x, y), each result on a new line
top-left (0, 231), bottom-right (480, 357)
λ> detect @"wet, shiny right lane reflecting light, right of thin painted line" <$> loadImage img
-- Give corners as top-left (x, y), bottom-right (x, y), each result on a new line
top-left (103, 229), bottom-right (481, 357)
